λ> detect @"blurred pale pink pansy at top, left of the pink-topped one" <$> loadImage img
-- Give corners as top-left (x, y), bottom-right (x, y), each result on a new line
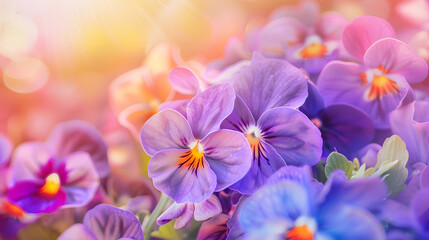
top-left (260, 2), bottom-right (347, 74)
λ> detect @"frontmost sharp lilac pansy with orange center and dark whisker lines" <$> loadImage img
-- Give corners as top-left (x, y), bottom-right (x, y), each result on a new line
top-left (140, 83), bottom-right (251, 203)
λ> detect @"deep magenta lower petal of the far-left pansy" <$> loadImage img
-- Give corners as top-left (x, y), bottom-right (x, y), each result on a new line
top-left (8, 180), bottom-right (66, 213)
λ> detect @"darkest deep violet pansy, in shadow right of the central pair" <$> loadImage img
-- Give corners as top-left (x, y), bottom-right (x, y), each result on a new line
top-left (299, 82), bottom-right (374, 157)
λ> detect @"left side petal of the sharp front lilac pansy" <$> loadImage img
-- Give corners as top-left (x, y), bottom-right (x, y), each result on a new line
top-left (140, 109), bottom-right (195, 156)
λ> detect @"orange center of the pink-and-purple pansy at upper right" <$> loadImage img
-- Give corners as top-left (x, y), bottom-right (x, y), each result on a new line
top-left (359, 65), bottom-right (399, 101)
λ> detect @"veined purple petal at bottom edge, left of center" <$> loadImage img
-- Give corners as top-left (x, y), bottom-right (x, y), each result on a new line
top-left (83, 204), bottom-right (143, 240)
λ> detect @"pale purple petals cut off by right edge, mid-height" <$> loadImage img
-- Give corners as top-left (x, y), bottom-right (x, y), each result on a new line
top-left (390, 101), bottom-right (429, 165)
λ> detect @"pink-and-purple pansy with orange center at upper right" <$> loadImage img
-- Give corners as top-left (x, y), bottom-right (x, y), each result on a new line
top-left (318, 16), bottom-right (428, 129)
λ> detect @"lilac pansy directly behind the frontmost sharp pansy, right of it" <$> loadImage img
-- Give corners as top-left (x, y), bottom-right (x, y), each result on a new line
top-left (222, 54), bottom-right (322, 194)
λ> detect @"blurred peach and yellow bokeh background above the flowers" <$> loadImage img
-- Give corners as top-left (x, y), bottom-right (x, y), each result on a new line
top-left (0, 0), bottom-right (428, 144)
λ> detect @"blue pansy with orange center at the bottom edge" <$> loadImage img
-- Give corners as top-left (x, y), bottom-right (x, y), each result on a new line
top-left (230, 166), bottom-right (387, 240)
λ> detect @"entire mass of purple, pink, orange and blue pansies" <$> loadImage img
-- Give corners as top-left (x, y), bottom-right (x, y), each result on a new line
top-left (0, 0), bottom-right (429, 240)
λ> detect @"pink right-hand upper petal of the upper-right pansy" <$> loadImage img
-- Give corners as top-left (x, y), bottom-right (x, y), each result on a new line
top-left (364, 38), bottom-right (428, 83)
